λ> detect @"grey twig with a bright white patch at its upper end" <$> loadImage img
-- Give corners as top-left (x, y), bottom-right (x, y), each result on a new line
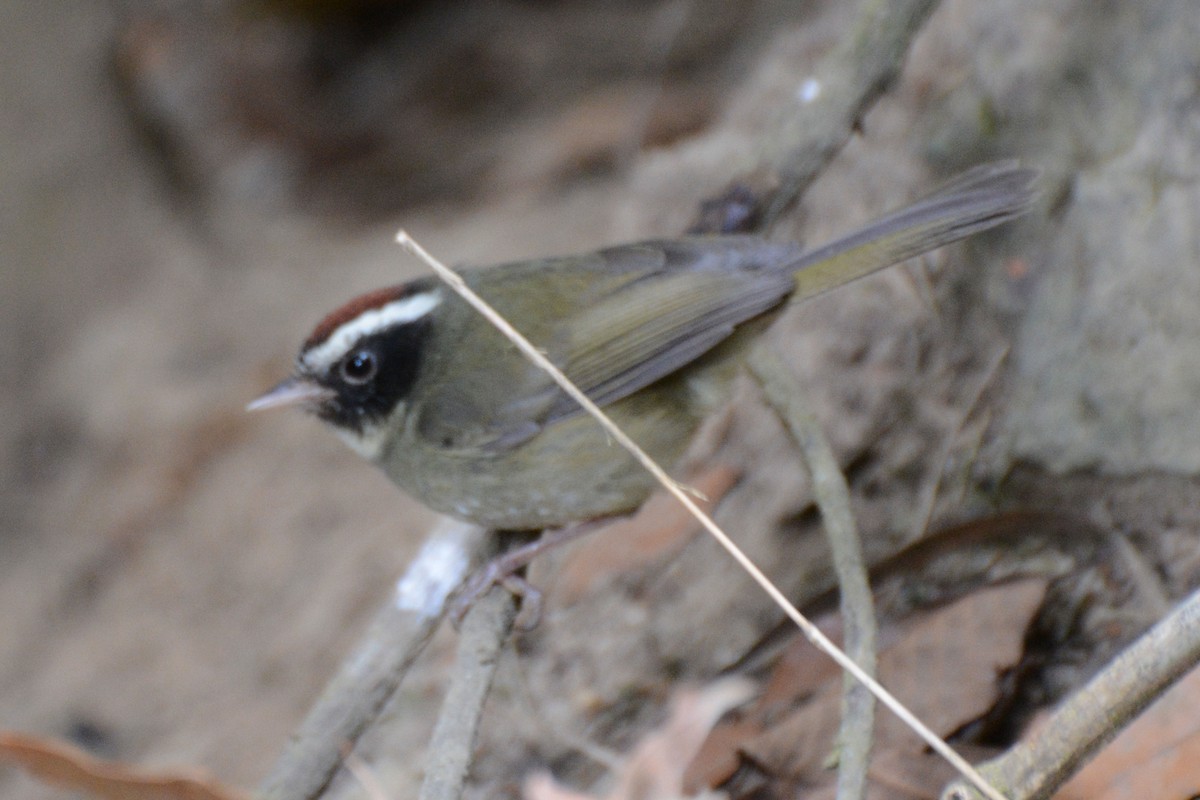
top-left (258, 523), bottom-right (496, 800)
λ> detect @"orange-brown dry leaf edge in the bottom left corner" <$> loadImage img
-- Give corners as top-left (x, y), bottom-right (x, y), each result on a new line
top-left (0, 732), bottom-right (250, 800)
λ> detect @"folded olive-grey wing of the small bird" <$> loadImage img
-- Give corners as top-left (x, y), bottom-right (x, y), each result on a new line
top-left (421, 236), bottom-right (798, 451)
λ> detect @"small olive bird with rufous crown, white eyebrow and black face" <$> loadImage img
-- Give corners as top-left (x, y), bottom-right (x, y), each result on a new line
top-left (248, 162), bottom-right (1037, 530)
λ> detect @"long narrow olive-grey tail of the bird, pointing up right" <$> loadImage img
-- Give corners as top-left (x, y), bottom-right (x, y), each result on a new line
top-left (791, 161), bottom-right (1038, 302)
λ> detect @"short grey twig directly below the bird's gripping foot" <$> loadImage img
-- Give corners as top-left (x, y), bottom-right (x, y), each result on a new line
top-left (419, 585), bottom-right (517, 800)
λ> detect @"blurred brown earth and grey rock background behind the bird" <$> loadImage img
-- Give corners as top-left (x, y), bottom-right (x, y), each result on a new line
top-left (7, 0), bottom-right (1200, 800)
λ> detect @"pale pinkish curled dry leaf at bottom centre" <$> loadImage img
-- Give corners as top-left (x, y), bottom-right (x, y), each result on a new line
top-left (524, 678), bottom-right (754, 800)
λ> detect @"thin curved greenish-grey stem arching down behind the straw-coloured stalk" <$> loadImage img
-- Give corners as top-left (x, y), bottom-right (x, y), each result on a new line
top-left (750, 347), bottom-right (877, 800)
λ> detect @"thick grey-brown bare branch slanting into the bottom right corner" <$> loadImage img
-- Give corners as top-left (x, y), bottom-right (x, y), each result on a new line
top-left (942, 582), bottom-right (1200, 800)
